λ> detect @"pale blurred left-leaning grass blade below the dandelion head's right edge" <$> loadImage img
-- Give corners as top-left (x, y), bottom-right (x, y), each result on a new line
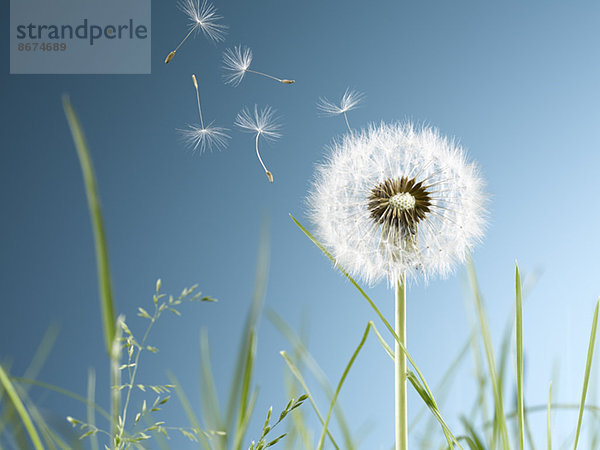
top-left (467, 259), bottom-right (510, 450)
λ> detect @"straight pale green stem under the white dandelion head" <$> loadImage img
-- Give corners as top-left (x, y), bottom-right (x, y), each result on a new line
top-left (394, 275), bottom-right (408, 450)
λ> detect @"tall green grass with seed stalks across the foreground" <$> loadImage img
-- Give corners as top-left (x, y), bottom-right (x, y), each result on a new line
top-left (0, 98), bottom-right (600, 450)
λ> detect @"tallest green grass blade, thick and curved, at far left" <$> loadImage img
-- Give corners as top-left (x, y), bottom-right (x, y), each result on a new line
top-left (63, 96), bottom-right (116, 354)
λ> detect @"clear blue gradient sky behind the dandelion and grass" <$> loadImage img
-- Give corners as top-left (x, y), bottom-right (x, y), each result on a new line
top-left (0, 0), bottom-right (600, 449)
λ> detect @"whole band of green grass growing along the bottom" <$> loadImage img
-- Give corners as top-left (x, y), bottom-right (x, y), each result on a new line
top-left (0, 97), bottom-right (600, 450)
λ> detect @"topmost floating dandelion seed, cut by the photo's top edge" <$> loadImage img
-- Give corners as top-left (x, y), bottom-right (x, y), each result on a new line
top-left (165, 0), bottom-right (227, 64)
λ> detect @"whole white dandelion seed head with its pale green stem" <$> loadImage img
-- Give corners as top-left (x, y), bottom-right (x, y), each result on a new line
top-left (309, 123), bottom-right (486, 450)
